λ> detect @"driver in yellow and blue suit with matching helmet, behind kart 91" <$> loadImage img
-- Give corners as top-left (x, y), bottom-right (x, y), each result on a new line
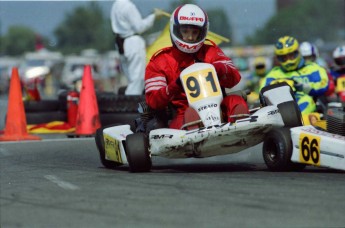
top-left (260, 36), bottom-right (328, 114)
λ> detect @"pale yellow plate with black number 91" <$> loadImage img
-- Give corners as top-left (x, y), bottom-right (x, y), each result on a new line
top-left (182, 68), bottom-right (221, 103)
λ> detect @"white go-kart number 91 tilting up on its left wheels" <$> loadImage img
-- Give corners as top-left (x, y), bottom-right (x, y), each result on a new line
top-left (95, 63), bottom-right (304, 172)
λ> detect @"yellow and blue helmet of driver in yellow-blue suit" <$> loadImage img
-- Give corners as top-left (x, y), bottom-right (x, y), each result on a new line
top-left (274, 36), bottom-right (302, 71)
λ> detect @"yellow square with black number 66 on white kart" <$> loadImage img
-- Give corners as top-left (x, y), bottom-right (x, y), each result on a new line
top-left (299, 133), bottom-right (321, 166)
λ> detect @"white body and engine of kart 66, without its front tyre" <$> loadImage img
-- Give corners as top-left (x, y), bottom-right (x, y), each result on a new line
top-left (291, 103), bottom-right (345, 170)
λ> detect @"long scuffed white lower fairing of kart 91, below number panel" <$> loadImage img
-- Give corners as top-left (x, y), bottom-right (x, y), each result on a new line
top-left (149, 106), bottom-right (284, 158)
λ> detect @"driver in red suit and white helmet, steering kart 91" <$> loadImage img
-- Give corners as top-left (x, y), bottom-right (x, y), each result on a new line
top-left (145, 4), bottom-right (249, 129)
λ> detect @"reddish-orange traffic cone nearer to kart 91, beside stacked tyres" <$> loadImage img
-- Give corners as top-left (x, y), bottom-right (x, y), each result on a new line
top-left (75, 65), bottom-right (101, 135)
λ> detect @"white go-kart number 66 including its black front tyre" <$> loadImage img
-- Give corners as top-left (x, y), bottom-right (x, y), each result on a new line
top-left (264, 75), bottom-right (345, 171)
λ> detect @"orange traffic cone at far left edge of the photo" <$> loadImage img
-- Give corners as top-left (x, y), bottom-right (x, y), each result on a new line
top-left (0, 67), bottom-right (41, 141)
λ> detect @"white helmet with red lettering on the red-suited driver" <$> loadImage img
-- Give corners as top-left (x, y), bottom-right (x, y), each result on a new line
top-left (170, 4), bottom-right (208, 53)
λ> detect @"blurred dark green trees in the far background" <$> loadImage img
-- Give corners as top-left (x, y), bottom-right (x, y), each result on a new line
top-left (0, 0), bottom-right (345, 56)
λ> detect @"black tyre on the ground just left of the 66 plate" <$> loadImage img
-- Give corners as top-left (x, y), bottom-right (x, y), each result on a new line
top-left (262, 128), bottom-right (305, 172)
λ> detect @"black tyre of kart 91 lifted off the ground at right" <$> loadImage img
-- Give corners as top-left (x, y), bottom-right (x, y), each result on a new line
top-left (278, 101), bottom-right (302, 128)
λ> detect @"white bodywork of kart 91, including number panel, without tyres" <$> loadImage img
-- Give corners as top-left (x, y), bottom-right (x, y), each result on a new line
top-left (103, 63), bottom-right (293, 164)
